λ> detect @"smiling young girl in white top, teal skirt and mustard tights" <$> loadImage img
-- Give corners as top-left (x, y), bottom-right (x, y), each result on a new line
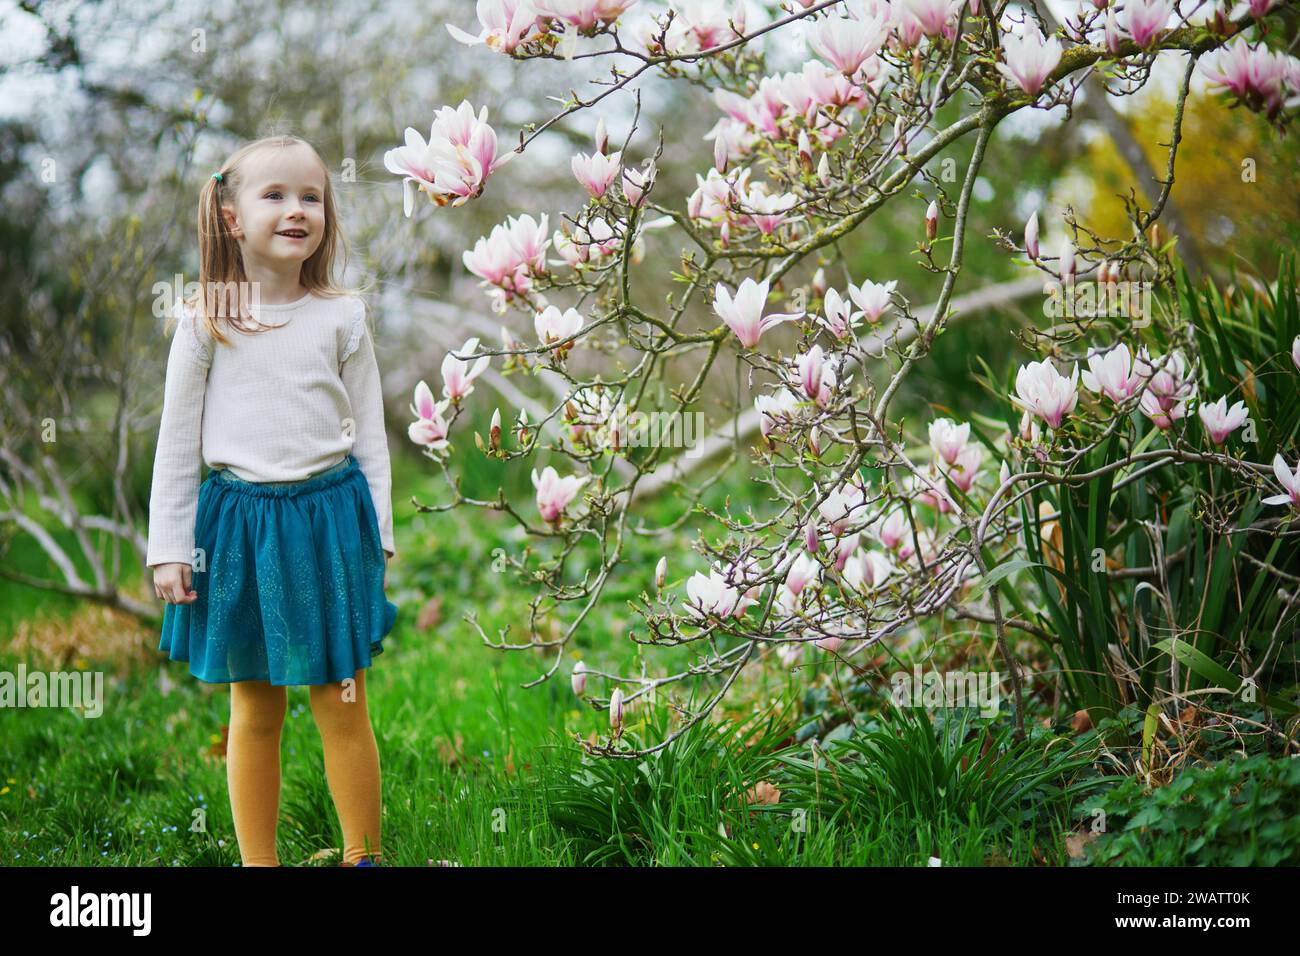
top-left (146, 137), bottom-right (397, 866)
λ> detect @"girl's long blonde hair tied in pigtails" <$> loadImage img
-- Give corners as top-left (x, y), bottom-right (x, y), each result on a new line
top-left (185, 134), bottom-right (361, 345)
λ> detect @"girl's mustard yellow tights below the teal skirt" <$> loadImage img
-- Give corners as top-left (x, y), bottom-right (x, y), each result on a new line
top-left (226, 670), bottom-right (381, 866)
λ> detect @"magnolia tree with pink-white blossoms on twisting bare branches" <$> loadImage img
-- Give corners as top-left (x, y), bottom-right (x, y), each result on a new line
top-left (385, 0), bottom-right (1300, 757)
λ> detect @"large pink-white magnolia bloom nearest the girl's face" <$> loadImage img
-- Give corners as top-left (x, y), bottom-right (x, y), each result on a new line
top-left (384, 100), bottom-right (519, 216)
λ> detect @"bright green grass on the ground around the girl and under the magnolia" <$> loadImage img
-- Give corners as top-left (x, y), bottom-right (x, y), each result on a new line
top-left (0, 455), bottom-right (1263, 866)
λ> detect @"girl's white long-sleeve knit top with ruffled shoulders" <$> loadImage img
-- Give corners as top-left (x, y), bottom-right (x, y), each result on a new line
top-left (146, 293), bottom-right (397, 567)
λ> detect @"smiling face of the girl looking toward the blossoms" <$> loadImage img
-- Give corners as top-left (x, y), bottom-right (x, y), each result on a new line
top-left (221, 144), bottom-right (325, 267)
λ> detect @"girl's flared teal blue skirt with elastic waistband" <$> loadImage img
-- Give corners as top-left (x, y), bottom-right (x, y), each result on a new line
top-left (159, 455), bottom-right (398, 685)
